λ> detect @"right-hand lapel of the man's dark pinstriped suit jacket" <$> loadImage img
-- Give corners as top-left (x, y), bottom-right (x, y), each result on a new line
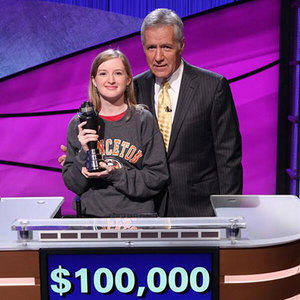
top-left (167, 62), bottom-right (196, 157)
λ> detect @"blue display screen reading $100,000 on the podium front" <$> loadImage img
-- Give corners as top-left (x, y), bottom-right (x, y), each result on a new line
top-left (41, 249), bottom-right (219, 300)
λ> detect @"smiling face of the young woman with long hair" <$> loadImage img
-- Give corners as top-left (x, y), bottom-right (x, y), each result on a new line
top-left (93, 58), bottom-right (131, 103)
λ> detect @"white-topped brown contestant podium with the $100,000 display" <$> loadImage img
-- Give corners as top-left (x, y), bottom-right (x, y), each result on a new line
top-left (0, 195), bottom-right (300, 300)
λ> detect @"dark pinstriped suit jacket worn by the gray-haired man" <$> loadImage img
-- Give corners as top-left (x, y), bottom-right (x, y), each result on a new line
top-left (134, 62), bottom-right (243, 217)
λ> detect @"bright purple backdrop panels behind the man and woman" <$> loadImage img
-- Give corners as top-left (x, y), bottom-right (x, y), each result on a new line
top-left (0, 0), bottom-right (280, 214)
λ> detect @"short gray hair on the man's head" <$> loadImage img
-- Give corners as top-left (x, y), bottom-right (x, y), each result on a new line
top-left (141, 8), bottom-right (183, 46)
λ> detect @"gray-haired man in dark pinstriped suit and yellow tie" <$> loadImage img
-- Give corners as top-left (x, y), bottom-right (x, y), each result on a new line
top-left (134, 9), bottom-right (242, 217)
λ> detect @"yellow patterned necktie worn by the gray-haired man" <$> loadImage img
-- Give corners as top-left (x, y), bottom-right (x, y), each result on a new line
top-left (157, 81), bottom-right (172, 152)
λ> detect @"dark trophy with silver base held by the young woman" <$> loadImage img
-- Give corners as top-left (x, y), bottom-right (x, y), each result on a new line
top-left (78, 101), bottom-right (104, 172)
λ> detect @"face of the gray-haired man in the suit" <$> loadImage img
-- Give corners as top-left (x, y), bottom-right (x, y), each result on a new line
top-left (144, 25), bottom-right (184, 78)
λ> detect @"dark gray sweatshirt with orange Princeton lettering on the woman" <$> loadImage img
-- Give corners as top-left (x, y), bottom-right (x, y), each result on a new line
top-left (63, 108), bottom-right (169, 217)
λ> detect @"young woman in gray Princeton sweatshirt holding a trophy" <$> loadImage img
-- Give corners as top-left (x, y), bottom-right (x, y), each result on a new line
top-left (63, 49), bottom-right (168, 217)
